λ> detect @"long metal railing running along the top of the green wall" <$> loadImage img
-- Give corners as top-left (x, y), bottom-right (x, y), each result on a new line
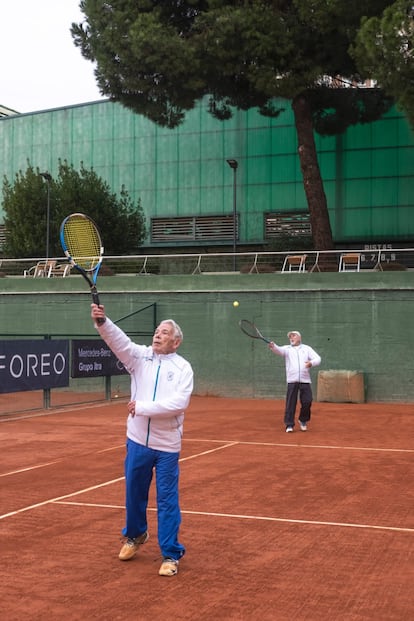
top-left (0, 247), bottom-right (414, 278)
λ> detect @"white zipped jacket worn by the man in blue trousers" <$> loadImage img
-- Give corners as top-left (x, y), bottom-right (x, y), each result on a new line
top-left (96, 317), bottom-right (194, 453)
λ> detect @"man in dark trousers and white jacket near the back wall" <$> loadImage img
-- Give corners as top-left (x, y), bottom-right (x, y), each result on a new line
top-left (269, 330), bottom-right (321, 433)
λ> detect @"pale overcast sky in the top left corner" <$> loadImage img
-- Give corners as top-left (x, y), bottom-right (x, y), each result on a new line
top-left (0, 0), bottom-right (102, 112)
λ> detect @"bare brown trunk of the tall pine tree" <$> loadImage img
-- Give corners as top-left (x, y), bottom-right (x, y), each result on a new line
top-left (292, 95), bottom-right (334, 250)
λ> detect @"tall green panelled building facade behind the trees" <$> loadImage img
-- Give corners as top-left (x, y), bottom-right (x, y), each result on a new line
top-left (0, 101), bottom-right (414, 245)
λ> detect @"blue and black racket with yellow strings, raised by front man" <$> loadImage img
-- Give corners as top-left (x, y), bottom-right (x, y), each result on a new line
top-left (60, 213), bottom-right (104, 324)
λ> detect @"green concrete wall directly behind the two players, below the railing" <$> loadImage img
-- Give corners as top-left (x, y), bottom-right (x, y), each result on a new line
top-left (0, 271), bottom-right (414, 402)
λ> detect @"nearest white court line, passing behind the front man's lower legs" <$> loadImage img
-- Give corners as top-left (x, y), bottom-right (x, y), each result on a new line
top-left (54, 501), bottom-right (414, 533)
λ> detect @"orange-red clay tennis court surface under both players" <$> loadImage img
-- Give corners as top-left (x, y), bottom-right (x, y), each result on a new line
top-left (0, 397), bottom-right (414, 621)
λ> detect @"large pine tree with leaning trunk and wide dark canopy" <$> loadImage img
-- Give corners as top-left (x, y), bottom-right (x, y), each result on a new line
top-left (72, 0), bottom-right (404, 249)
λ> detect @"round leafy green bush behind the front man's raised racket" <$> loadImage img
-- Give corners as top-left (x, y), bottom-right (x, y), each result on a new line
top-left (3, 162), bottom-right (146, 258)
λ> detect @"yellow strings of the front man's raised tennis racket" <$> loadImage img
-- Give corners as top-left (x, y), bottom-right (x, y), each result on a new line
top-left (64, 217), bottom-right (102, 271)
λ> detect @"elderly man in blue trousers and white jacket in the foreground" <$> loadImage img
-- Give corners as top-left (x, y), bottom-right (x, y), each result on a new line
top-left (91, 304), bottom-right (193, 576)
